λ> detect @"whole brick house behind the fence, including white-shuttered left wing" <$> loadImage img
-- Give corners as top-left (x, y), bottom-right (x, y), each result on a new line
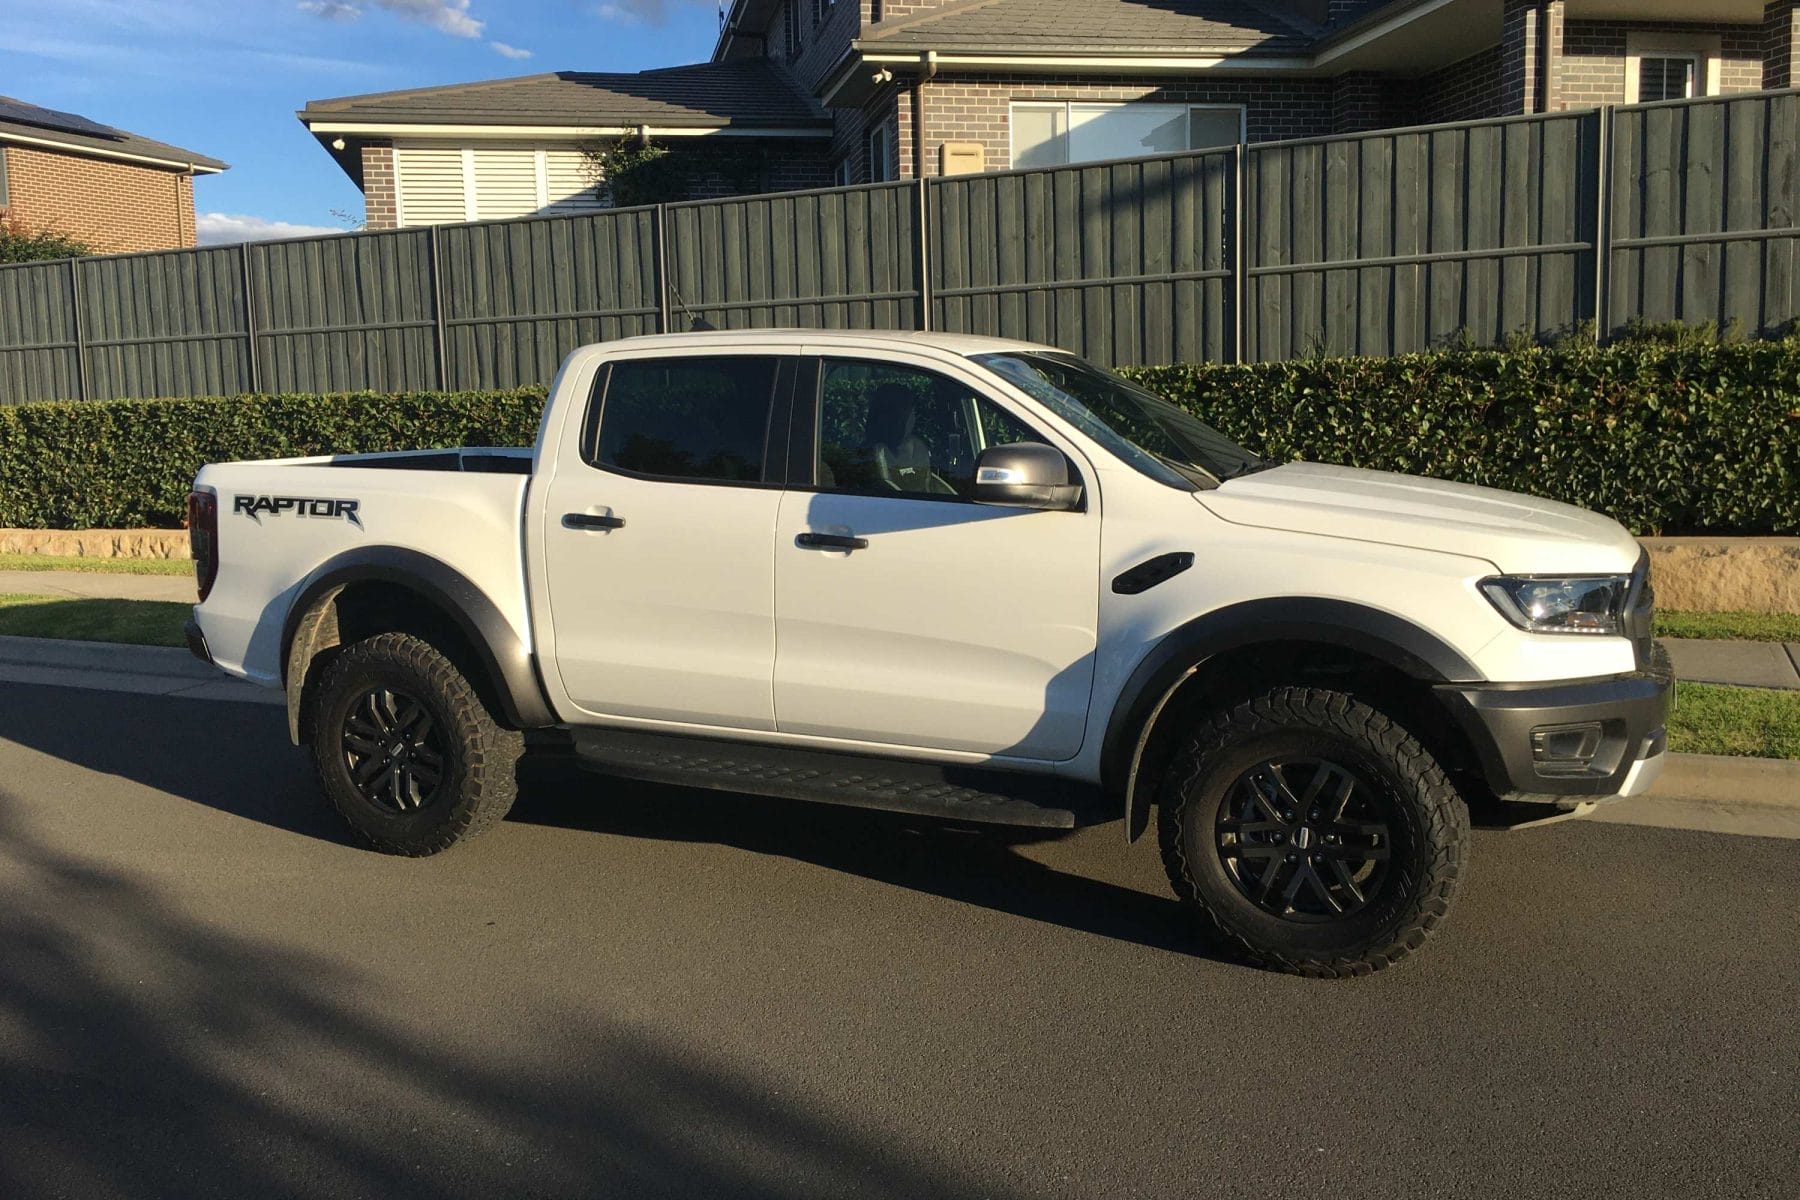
top-left (301, 0), bottom-right (1800, 228)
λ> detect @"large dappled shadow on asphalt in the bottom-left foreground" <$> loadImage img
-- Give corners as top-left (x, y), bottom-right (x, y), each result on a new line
top-left (0, 792), bottom-right (1004, 1200)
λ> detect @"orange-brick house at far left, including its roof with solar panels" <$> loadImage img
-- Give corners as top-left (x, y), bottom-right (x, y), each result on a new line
top-left (0, 95), bottom-right (225, 252)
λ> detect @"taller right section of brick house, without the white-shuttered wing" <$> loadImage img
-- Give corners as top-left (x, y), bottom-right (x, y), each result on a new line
top-left (745, 0), bottom-right (1800, 182)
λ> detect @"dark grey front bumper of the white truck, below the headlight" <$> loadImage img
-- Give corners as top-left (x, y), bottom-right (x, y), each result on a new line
top-left (1435, 648), bottom-right (1674, 806)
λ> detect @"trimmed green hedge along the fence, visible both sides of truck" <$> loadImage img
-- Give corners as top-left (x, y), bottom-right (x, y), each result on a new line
top-left (0, 333), bottom-right (1800, 534)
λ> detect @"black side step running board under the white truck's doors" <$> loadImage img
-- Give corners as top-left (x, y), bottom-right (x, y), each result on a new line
top-left (574, 729), bottom-right (1082, 829)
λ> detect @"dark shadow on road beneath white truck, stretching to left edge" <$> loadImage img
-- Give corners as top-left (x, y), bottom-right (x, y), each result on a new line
top-left (0, 684), bottom-right (1215, 957)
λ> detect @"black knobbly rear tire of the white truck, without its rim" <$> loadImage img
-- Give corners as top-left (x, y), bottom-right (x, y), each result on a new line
top-left (311, 633), bottom-right (524, 858)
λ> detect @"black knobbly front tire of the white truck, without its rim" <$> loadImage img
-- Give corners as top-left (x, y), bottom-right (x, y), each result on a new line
top-left (1157, 687), bottom-right (1469, 979)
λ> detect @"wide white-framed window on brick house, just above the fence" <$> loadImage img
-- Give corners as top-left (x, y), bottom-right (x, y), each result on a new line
top-left (1012, 101), bottom-right (1244, 167)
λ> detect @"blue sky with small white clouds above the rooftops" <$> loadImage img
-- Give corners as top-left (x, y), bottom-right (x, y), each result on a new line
top-left (0, 0), bottom-right (718, 241)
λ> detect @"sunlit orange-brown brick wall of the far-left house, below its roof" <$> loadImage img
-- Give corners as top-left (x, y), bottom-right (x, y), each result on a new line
top-left (4, 146), bottom-right (194, 254)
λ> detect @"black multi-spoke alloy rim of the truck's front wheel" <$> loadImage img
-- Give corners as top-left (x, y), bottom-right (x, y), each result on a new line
top-left (1215, 757), bottom-right (1395, 921)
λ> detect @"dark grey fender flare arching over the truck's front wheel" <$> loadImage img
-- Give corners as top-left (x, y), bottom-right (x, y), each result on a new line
top-left (1100, 596), bottom-right (1485, 842)
